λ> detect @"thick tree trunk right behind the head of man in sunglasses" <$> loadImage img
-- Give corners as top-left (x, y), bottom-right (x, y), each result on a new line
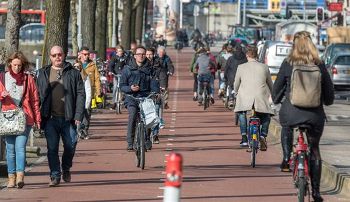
top-left (42, 0), bottom-right (70, 65)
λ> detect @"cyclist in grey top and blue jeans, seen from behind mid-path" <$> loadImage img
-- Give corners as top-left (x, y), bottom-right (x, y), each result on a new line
top-left (194, 47), bottom-right (215, 105)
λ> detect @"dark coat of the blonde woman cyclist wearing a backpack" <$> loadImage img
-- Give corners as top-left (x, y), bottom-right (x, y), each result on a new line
top-left (272, 61), bottom-right (334, 127)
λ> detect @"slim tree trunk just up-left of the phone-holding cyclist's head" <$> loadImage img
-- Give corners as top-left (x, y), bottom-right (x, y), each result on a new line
top-left (121, 0), bottom-right (132, 49)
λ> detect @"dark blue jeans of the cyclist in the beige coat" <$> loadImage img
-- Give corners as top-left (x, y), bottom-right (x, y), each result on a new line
top-left (238, 111), bottom-right (271, 137)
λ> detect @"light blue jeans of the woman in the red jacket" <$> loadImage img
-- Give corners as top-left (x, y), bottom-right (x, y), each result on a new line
top-left (5, 126), bottom-right (32, 174)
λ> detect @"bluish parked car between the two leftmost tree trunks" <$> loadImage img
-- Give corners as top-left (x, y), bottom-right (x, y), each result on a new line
top-left (19, 23), bottom-right (45, 41)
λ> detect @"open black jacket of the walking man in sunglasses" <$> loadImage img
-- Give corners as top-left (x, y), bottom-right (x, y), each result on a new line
top-left (36, 62), bottom-right (85, 126)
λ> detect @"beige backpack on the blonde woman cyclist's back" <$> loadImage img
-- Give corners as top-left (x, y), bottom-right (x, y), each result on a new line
top-left (289, 65), bottom-right (321, 108)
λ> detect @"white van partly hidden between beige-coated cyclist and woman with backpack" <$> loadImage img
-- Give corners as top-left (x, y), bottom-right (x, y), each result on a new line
top-left (258, 41), bottom-right (292, 80)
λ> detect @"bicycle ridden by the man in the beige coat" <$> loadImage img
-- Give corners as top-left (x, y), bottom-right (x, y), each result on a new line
top-left (248, 109), bottom-right (261, 168)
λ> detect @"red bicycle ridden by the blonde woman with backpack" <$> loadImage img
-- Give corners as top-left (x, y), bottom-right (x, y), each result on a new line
top-left (290, 125), bottom-right (311, 202)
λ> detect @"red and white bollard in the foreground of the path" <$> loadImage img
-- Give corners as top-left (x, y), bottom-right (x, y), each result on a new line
top-left (163, 153), bottom-right (182, 202)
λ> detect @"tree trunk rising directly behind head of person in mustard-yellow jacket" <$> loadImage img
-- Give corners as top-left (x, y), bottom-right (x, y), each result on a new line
top-left (81, 0), bottom-right (96, 51)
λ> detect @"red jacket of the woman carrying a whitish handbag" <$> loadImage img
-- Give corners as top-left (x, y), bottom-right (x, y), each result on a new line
top-left (0, 73), bottom-right (41, 126)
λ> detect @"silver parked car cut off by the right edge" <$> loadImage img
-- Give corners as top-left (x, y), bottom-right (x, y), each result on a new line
top-left (328, 52), bottom-right (350, 88)
